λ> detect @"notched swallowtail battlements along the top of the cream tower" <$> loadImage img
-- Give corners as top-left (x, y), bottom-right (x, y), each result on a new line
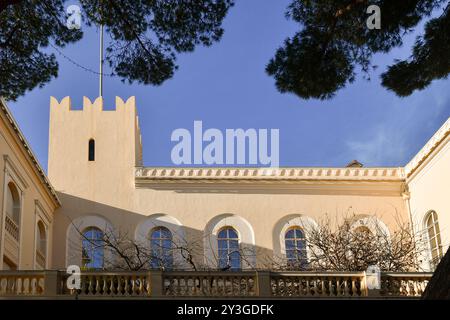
top-left (50, 96), bottom-right (136, 112)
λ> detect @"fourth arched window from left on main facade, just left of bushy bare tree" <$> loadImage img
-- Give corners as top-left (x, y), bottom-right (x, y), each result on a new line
top-left (284, 227), bottom-right (307, 268)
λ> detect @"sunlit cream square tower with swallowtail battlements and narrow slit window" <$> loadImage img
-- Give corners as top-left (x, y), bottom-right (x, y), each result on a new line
top-left (48, 97), bottom-right (142, 207)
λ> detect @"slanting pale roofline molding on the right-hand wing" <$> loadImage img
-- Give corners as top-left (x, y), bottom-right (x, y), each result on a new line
top-left (405, 118), bottom-right (450, 178)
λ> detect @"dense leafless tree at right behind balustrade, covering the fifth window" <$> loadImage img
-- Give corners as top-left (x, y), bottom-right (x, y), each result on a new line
top-left (275, 215), bottom-right (426, 272)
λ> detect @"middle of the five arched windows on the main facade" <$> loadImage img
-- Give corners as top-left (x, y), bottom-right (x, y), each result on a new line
top-left (217, 227), bottom-right (241, 270)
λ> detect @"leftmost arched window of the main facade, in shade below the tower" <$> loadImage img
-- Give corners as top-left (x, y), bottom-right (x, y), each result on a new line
top-left (81, 227), bottom-right (104, 269)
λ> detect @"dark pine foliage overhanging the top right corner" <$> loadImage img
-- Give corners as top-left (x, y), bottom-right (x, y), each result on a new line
top-left (266, 0), bottom-right (450, 99)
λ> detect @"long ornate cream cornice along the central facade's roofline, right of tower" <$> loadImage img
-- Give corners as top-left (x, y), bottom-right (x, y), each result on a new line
top-left (135, 168), bottom-right (405, 196)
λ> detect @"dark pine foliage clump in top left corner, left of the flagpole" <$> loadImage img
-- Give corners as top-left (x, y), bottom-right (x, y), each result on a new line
top-left (0, 0), bottom-right (82, 100)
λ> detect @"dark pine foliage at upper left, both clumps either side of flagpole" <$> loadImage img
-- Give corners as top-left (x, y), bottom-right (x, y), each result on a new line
top-left (0, 0), bottom-right (233, 100)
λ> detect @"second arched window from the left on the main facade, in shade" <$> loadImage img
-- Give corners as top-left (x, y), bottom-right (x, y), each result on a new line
top-left (150, 227), bottom-right (173, 269)
